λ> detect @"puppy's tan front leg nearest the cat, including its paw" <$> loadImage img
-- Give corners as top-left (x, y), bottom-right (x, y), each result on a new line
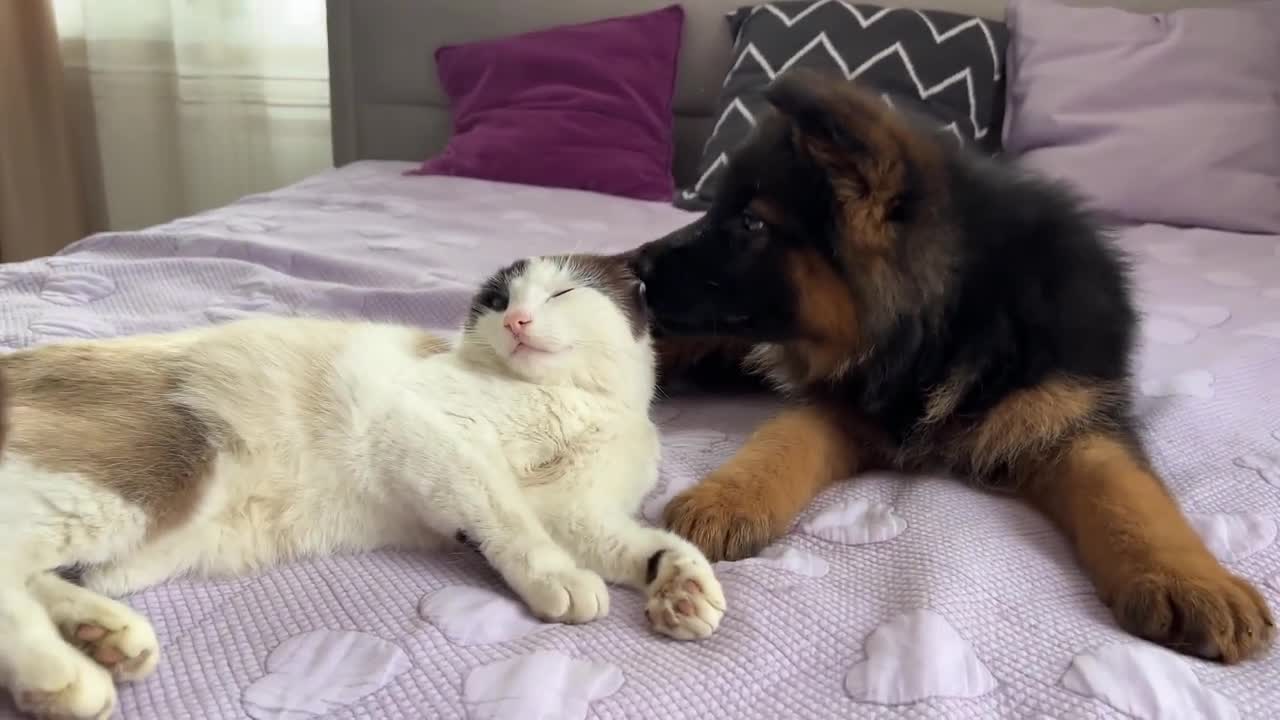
top-left (664, 407), bottom-right (865, 562)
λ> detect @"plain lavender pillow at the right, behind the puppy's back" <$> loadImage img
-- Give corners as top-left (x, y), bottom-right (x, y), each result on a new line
top-left (1005, 0), bottom-right (1280, 233)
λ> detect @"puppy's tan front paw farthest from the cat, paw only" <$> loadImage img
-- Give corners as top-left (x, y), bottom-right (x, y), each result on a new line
top-left (1111, 559), bottom-right (1275, 664)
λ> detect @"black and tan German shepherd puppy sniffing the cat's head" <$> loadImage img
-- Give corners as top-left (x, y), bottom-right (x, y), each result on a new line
top-left (630, 70), bottom-right (1274, 662)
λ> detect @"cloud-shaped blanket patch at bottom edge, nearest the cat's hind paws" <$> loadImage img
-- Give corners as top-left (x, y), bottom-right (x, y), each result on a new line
top-left (241, 630), bottom-right (411, 720)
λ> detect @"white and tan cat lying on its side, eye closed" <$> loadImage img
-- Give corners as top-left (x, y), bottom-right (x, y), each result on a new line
top-left (0, 256), bottom-right (724, 719)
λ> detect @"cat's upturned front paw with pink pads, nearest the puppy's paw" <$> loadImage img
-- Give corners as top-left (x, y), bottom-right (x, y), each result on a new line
top-left (645, 548), bottom-right (724, 641)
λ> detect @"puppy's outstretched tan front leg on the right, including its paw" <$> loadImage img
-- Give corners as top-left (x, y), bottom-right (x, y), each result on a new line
top-left (1027, 434), bottom-right (1275, 662)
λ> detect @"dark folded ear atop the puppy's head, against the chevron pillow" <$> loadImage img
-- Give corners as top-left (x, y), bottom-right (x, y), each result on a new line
top-left (764, 68), bottom-right (865, 151)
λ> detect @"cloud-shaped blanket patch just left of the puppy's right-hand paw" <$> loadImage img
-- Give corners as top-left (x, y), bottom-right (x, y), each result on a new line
top-left (845, 609), bottom-right (996, 705)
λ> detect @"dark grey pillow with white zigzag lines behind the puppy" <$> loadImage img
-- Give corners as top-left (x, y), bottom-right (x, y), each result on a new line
top-left (675, 0), bottom-right (1009, 210)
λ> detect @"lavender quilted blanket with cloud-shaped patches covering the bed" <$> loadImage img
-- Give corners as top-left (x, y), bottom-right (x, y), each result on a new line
top-left (0, 163), bottom-right (1280, 720)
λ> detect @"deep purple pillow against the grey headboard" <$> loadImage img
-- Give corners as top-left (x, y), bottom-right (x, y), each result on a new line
top-left (412, 5), bottom-right (685, 201)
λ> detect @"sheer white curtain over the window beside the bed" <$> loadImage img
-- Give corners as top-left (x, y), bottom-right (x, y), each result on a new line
top-left (54, 0), bottom-right (332, 229)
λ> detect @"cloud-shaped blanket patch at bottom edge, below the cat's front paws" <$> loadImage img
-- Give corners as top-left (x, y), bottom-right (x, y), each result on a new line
top-left (462, 651), bottom-right (623, 720)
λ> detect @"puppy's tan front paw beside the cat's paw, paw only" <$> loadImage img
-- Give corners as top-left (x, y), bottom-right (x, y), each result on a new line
top-left (663, 474), bottom-right (776, 562)
